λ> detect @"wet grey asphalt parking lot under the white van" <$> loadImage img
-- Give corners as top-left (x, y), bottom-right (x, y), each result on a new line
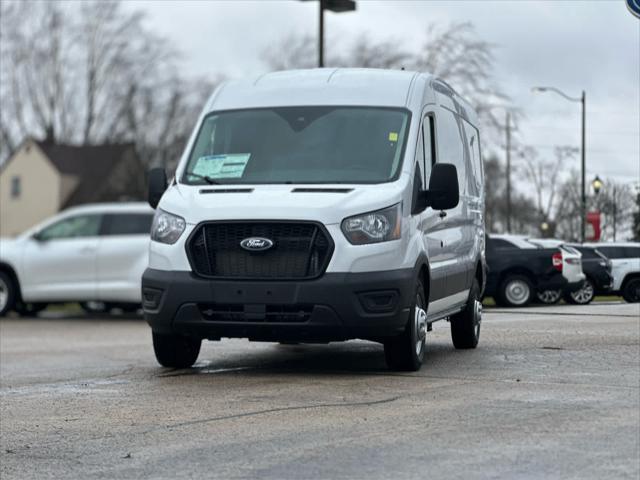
top-left (0, 303), bottom-right (640, 480)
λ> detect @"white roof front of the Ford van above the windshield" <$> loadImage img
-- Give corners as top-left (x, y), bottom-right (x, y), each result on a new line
top-left (207, 68), bottom-right (433, 111)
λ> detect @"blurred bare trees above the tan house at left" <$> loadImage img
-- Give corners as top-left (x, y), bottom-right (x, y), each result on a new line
top-left (0, 0), bottom-right (217, 169)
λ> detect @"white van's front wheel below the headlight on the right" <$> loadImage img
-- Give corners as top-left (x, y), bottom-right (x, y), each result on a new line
top-left (384, 280), bottom-right (427, 372)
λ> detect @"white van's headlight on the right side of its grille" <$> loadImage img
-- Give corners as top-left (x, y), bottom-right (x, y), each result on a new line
top-left (342, 203), bottom-right (402, 245)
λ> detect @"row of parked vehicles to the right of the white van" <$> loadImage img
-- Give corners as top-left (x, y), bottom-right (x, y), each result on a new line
top-left (485, 235), bottom-right (640, 307)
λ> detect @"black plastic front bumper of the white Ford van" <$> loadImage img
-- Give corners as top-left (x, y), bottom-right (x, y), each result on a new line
top-left (142, 269), bottom-right (415, 342)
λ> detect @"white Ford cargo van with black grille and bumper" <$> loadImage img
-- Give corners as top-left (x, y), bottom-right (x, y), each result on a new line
top-left (142, 69), bottom-right (485, 370)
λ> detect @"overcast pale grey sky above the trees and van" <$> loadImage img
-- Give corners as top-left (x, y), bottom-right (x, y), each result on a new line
top-left (127, 0), bottom-right (640, 188)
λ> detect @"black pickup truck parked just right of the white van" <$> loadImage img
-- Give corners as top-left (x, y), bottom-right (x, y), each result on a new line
top-left (484, 235), bottom-right (582, 307)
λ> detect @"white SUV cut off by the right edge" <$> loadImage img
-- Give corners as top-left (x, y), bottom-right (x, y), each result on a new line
top-left (588, 242), bottom-right (640, 303)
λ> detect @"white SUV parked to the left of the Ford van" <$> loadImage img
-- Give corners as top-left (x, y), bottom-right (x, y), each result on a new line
top-left (0, 203), bottom-right (153, 316)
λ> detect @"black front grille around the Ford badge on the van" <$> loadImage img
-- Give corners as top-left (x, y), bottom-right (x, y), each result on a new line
top-left (186, 222), bottom-right (333, 280)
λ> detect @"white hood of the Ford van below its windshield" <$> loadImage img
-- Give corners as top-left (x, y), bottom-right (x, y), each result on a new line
top-left (159, 182), bottom-right (404, 225)
